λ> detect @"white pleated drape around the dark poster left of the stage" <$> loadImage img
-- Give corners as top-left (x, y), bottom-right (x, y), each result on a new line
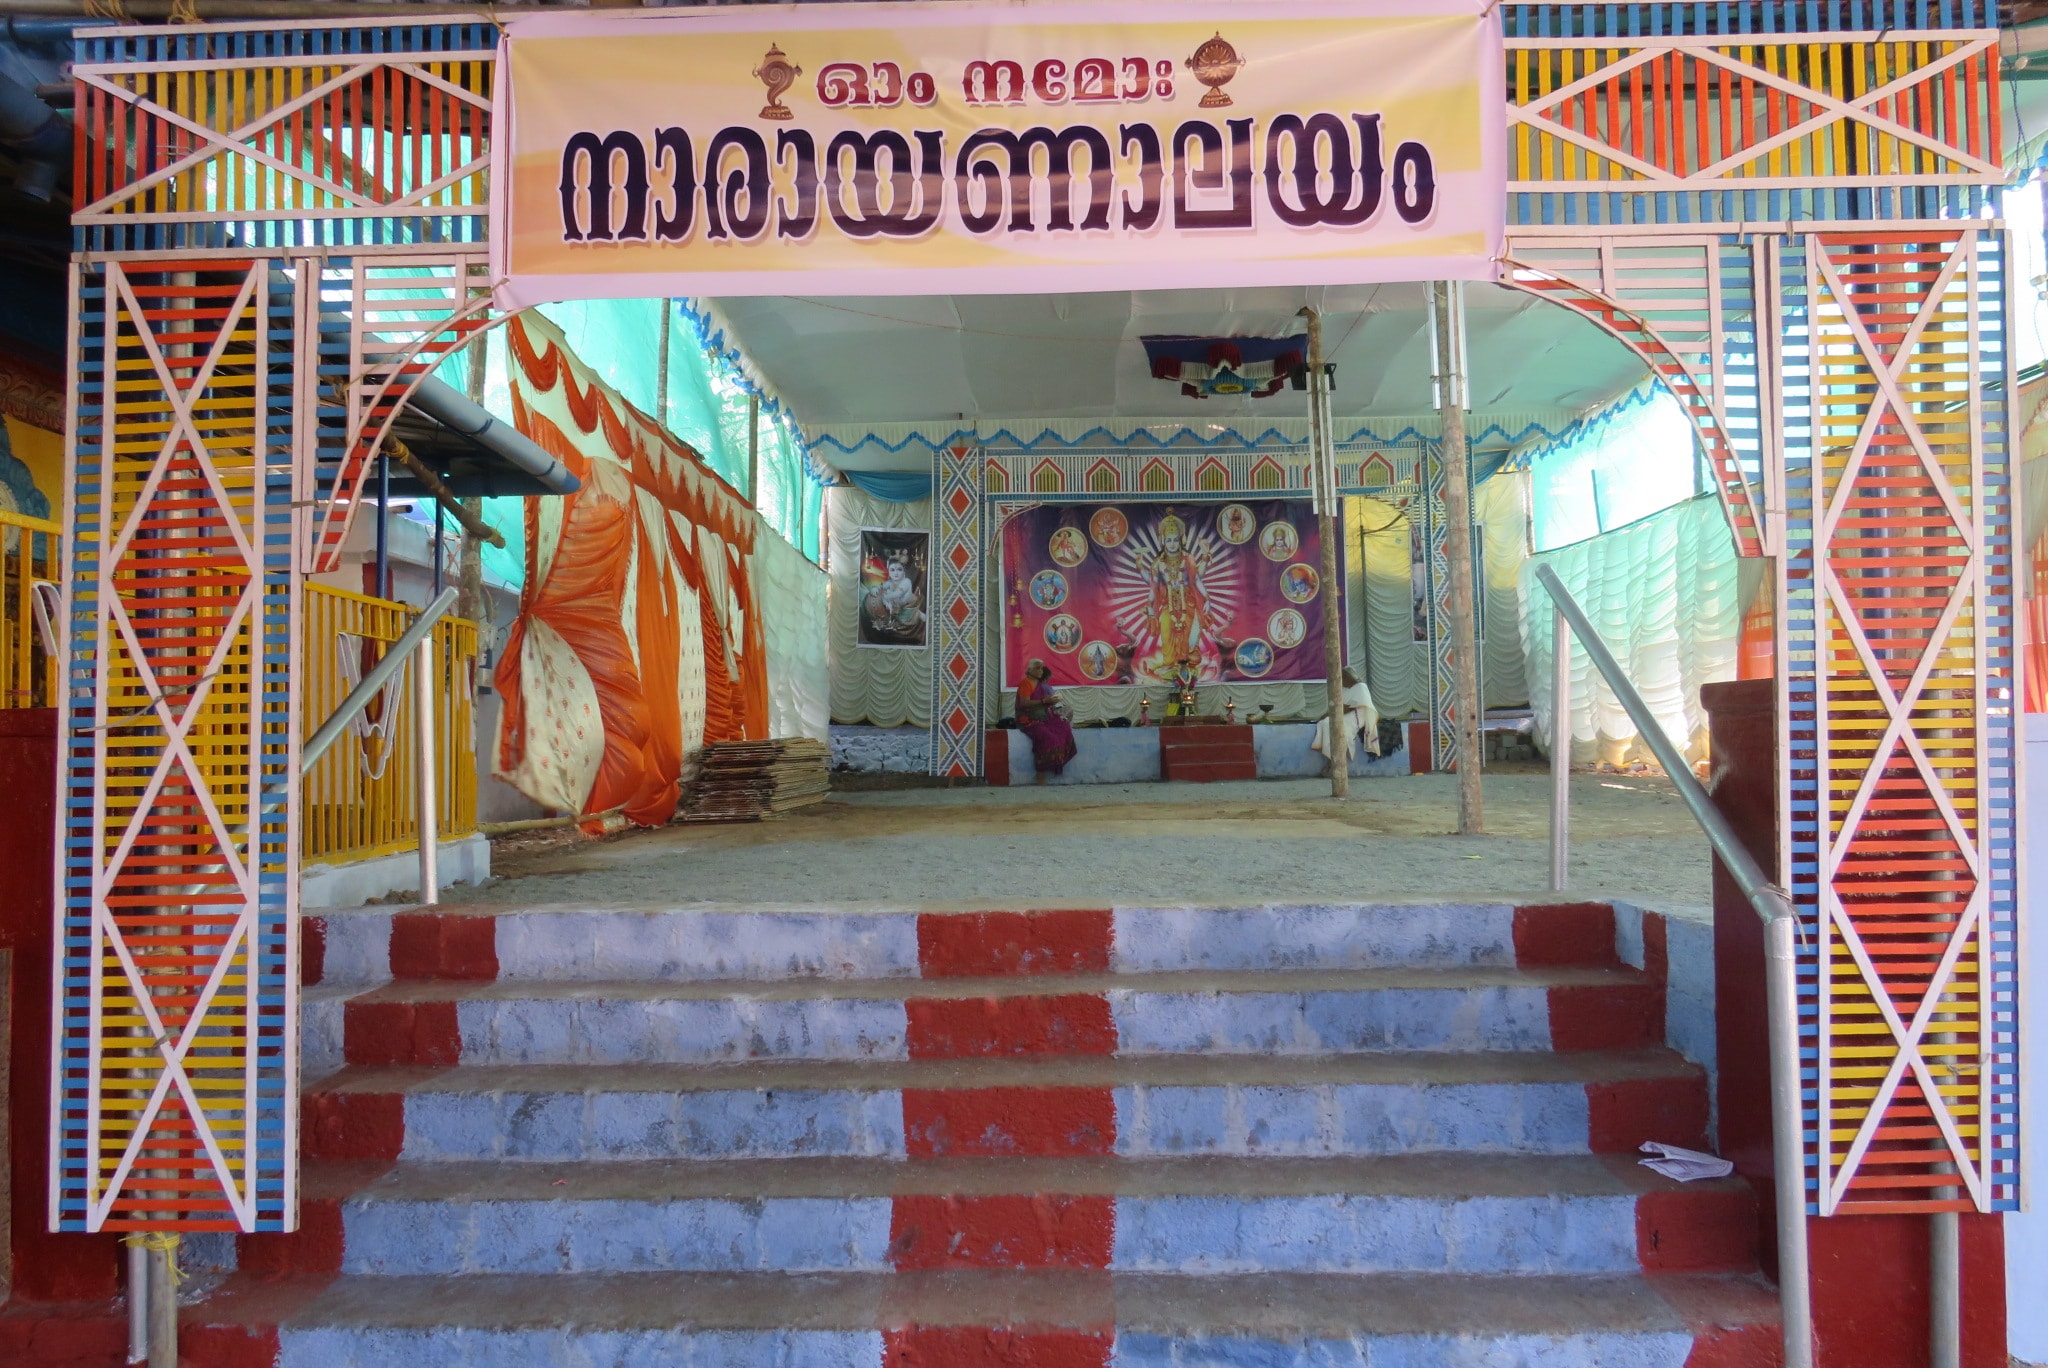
top-left (825, 485), bottom-right (932, 727)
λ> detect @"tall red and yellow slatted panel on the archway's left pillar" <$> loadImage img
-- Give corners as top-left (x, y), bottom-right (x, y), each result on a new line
top-left (57, 258), bottom-right (291, 1231)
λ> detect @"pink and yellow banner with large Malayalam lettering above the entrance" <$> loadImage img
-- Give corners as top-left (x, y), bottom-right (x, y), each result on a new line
top-left (492, 0), bottom-right (1507, 305)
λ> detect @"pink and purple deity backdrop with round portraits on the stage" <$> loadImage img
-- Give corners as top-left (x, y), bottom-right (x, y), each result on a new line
top-left (1001, 500), bottom-right (1341, 688)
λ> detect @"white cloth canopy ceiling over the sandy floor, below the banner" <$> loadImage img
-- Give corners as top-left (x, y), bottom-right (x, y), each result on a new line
top-left (719, 285), bottom-right (1645, 469)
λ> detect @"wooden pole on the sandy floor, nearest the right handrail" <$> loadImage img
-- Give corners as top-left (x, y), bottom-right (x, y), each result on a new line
top-left (1430, 281), bottom-right (1487, 836)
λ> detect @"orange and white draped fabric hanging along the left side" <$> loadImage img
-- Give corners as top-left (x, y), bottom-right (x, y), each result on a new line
top-left (496, 317), bottom-right (768, 825)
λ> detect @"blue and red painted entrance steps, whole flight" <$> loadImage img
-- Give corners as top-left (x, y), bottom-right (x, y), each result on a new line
top-left (211, 905), bottom-right (1778, 1368)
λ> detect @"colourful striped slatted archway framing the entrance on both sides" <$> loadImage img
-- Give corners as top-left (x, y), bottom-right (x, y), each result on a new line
top-left (51, 0), bottom-right (2017, 1253)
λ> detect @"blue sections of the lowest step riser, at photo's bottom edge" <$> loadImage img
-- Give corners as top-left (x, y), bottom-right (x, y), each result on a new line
top-left (279, 1325), bottom-right (1694, 1368)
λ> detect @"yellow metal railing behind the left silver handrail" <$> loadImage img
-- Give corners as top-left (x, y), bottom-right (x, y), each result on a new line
top-left (299, 584), bottom-right (477, 860)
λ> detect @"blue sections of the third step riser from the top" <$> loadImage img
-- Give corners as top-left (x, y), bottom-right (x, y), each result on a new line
top-left (401, 1083), bottom-right (1589, 1161)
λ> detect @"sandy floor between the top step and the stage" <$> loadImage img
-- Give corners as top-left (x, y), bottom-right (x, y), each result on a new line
top-left (446, 768), bottom-right (1712, 915)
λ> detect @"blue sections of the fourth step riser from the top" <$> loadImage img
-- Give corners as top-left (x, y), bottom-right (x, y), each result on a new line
top-left (342, 1196), bottom-right (1638, 1276)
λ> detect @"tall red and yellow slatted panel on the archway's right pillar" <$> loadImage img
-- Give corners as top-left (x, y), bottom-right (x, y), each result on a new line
top-left (1808, 229), bottom-right (1993, 1212)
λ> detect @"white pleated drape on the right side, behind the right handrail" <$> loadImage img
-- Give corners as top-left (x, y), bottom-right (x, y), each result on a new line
top-left (1522, 494), bottom-right (1743, 764)
